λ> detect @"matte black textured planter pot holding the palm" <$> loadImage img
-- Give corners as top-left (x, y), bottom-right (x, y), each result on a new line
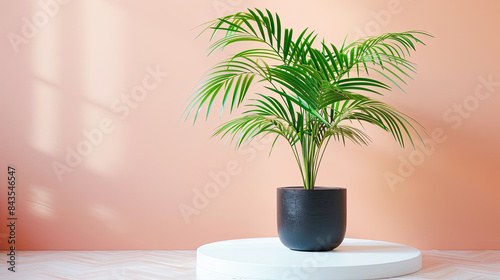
top-left (278, 187), bottom-right (347, 251)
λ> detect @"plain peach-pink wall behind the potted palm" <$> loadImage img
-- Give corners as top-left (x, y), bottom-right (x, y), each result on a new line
top-left (0, 0), bottom-right (500, 250)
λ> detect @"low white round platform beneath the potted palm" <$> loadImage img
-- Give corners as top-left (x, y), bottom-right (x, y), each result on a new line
top-left (197, 237), bottom-right (422, 280)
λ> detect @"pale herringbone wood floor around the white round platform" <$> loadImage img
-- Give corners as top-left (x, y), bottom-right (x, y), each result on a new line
top-left (0, 251), bottom-right (500, 280)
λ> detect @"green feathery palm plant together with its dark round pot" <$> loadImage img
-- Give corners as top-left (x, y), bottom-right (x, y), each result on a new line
top-left (184, 9), bottom-right (430, 251)
